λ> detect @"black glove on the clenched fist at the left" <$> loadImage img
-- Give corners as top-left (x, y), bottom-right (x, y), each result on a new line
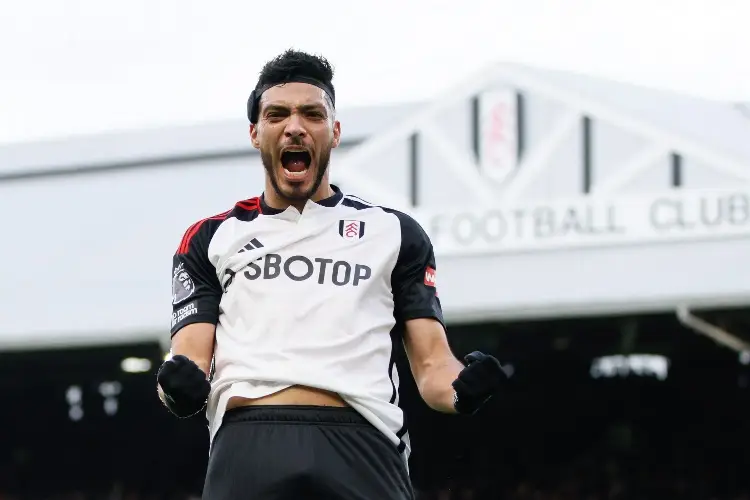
top-left (156, 355), bottom-right (211, 418)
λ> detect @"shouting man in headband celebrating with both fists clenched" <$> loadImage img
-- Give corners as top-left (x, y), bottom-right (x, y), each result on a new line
top-left (158, 50), bottom-right (505, 500)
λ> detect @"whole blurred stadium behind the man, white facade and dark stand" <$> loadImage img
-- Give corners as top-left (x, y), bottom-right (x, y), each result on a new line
top-left (0, 65), bottom-right (750, 500)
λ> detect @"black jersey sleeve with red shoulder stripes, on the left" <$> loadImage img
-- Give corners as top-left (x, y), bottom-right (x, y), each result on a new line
top-left (171, 221), bottom-right (222, 337)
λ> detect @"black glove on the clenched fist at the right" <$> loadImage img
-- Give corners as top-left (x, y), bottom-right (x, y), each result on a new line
top-left (453, 351), bottom-right (508, 414)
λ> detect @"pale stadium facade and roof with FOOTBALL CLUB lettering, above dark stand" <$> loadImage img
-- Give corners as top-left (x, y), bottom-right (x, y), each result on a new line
top-left (0, 61), bottom-right (750, 350)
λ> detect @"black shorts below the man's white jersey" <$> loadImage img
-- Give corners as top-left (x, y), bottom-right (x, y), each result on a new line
top-left (203, 406), bottom-right (414, 500)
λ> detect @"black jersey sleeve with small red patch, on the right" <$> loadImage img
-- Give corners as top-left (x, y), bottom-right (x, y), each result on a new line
top-left (391, 212), bottom-right (445, 327)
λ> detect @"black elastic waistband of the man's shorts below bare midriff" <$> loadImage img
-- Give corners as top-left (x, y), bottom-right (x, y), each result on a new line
top-left (222, 405), bottom-right (370, 426)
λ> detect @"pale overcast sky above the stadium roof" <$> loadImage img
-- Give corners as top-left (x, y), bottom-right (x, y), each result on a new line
top-left (0, 0), bottom-right (750, 142)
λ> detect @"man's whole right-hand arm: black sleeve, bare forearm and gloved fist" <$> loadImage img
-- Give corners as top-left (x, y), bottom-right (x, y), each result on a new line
top-left (391, 214), bottom-right (507, 413)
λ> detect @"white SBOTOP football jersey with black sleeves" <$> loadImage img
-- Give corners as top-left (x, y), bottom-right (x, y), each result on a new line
top-left (171, 186), bottom-right (443, 459)
